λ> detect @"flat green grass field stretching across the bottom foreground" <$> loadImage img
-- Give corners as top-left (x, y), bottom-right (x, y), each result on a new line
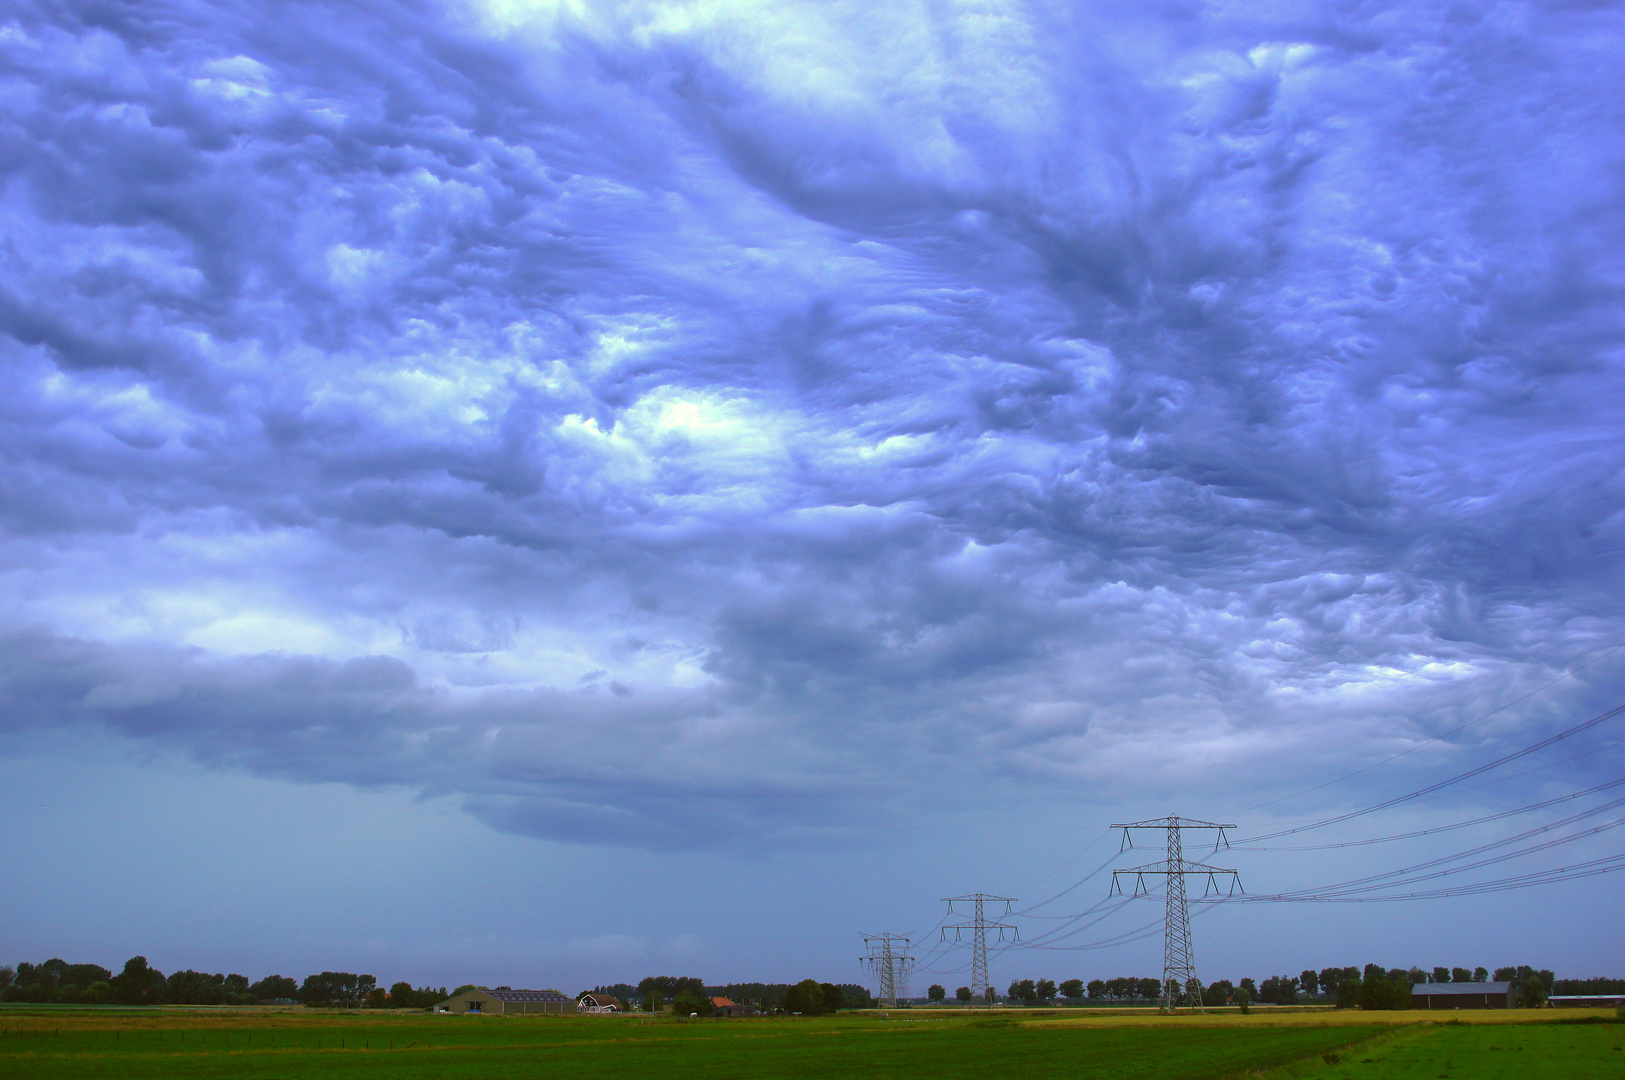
top-left (0, 1009), bottom-right (1625, 1080)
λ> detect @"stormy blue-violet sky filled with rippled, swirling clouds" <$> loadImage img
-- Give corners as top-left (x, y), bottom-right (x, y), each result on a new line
top-left (0, 0), bottom-right (1625, 992)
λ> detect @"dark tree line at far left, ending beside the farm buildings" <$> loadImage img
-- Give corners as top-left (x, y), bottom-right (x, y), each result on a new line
top-left (0, 957), bottom-right (458, 1009)
